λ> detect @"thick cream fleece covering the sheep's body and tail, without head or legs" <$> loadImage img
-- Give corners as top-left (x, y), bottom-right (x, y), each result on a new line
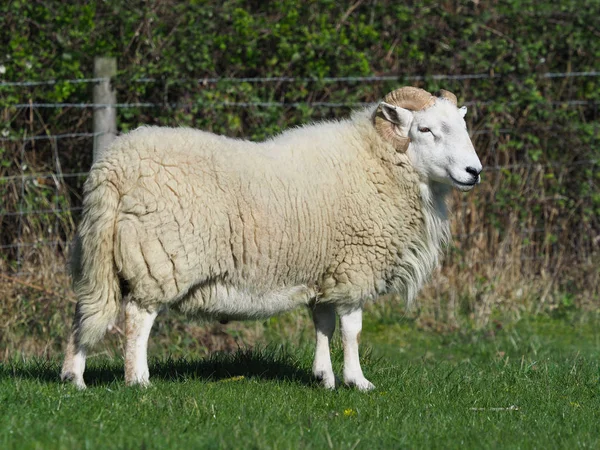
top-left (74, 108), bottom-right (448, 342)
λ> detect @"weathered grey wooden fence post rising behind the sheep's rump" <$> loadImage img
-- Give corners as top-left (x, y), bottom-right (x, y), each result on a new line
top-left (93, 56), bottom-right (117, 161)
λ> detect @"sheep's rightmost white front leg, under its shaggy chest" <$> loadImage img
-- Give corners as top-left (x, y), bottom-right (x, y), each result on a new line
top-left (338, 308), bottom-right (375, 391)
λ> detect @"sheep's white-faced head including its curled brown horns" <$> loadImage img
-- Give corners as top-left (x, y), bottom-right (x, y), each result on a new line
top-left (373, 87), bottom-right (482, 191)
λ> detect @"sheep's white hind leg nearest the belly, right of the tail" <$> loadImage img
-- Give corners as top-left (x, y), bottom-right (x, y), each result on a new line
top-left (125, 301), bottom-right (158, 386)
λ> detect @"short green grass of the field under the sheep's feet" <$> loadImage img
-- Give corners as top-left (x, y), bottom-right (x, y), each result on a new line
top-left (0, 311), bottom-right (600, 449)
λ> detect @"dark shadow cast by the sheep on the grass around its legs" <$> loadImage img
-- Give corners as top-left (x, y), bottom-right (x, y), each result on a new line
top-left (0, 348), bottom-right (316, 386)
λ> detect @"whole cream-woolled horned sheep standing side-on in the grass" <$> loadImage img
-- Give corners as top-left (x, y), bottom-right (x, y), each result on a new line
top-left (61, 87), bottom-right (482, 390)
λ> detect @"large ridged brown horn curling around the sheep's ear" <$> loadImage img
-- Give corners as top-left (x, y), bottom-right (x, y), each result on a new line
top-left (374, 86), bottom-right (434, 153)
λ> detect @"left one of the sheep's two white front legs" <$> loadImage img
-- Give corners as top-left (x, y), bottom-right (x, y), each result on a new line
top-left (312, 303), bottom-right (335, 389)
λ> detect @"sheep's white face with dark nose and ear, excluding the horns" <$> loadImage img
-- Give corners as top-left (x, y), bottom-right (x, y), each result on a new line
top-left (381, 98), bottom-right (482, 191)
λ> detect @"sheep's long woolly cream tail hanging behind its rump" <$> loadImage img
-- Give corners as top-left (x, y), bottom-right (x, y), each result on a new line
top-left (71, 170), bottom-right (121, 347)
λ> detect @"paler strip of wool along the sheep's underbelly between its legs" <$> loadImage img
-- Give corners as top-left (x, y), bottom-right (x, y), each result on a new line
top-left (177, 282), bottom-right (316, 320)
